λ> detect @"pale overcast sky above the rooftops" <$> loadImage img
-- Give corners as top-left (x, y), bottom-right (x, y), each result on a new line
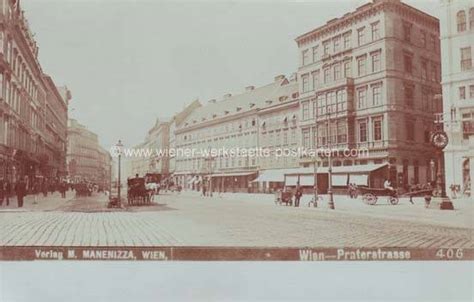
top-left (21, 0), bottom-right (439, 148)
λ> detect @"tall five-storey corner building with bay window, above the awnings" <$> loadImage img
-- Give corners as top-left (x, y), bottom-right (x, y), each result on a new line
top-left (296, 0), bottom-right (442, 187)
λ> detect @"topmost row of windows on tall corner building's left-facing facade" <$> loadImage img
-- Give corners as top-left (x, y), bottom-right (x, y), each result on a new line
top-left (301, 21), bottom-right (382, 66)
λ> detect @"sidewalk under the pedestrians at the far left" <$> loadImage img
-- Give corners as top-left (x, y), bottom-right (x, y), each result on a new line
top-left (0, 191), bottom-right (75, 212)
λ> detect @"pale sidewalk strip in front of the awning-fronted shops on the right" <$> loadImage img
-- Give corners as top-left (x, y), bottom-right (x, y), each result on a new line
top-left (181, 191), bottom-right (474, 229)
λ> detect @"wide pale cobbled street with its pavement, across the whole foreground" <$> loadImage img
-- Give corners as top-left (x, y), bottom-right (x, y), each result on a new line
top-left (0, 192), bottom-right (474, 248)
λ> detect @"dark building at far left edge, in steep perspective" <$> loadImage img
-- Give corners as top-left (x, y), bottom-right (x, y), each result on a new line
top-left (0, 0), bottom-right (69, 182)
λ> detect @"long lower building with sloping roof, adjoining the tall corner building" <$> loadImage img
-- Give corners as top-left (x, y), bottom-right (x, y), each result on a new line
top-left (175, 75), bottom-right (297, 192)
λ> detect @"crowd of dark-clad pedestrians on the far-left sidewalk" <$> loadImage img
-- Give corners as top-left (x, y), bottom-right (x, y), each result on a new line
top-left (0, 178), bottom-right (68, 208)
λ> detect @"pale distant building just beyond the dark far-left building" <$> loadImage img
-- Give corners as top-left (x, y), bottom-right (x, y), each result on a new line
top-left (67, 119), bottom-right (111, 185)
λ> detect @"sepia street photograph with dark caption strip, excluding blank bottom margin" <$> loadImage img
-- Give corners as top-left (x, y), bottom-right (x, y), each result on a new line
top-left (0, 0), bottom-right (474, 301)
